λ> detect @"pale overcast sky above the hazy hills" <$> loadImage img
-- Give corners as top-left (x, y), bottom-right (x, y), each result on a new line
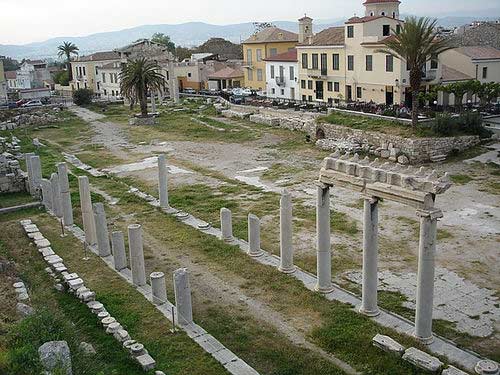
top-left (0, 0), bottom-right (500, 44)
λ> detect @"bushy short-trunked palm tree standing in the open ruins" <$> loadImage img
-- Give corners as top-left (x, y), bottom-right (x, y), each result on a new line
top-left (120, 58), bottom-right (166, 117)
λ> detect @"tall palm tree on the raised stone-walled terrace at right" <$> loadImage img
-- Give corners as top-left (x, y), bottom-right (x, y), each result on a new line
top-left (377, 17), bottom-right (452, 128)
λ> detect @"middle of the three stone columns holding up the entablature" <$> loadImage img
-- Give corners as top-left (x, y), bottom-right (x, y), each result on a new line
top-left (360, 198), bottom-right (380, 316)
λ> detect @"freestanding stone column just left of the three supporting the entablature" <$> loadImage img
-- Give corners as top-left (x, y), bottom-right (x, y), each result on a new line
top-left (279, 189), bottom-right (295, 273)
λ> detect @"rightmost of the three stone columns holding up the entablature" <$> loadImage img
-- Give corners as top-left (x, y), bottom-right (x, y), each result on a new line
top-left (415, 210), bottom-right (443, 344)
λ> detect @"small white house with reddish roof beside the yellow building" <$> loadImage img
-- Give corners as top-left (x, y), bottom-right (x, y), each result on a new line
top-left (264, 49), bottom-right (299, 100)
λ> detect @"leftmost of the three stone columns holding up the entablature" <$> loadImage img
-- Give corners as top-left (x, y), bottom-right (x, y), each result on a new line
top-left (316, 186), bottom-right (333, 293)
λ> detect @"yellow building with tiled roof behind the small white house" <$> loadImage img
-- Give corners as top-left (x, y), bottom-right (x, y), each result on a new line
top-left (243, 27), bottom-right (299, 91)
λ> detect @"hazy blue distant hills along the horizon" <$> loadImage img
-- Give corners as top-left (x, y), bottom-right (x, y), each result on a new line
top-left (0, 17), bottom-right (496, 59)
